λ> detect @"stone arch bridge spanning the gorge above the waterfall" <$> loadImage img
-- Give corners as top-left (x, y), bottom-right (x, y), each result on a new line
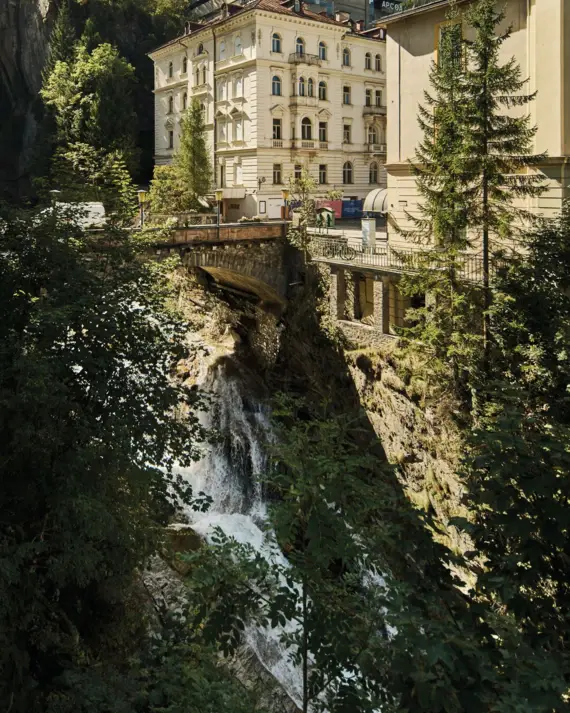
top-left (155, 221), bottom-right (290, 306)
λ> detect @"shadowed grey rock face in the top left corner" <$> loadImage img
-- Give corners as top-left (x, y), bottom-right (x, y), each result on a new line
top-left (0, 0), bottom-right (59, 197)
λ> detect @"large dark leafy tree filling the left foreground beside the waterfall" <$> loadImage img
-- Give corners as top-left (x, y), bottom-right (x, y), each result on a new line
top-left (0, 196), bottom-right (206, 713)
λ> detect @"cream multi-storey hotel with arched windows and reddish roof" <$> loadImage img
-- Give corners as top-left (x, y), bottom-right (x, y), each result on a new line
top-left (150, 0), bottom-right (386, 220)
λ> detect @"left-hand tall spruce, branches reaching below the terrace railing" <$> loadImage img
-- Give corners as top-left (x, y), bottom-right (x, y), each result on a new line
top-left (399, 3), bottom-right (478, 395)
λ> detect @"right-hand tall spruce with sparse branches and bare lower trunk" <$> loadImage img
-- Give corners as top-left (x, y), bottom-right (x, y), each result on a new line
top-left (464, 0), bottom-right (544, 345)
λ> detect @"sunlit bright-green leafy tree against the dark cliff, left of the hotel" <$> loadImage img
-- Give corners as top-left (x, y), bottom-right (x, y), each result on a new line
top-left (41, 44), bottom-right (136, 161)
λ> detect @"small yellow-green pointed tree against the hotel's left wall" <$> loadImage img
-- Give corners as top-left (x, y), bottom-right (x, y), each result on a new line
top-left (149, 99), bottom-right (212, 214)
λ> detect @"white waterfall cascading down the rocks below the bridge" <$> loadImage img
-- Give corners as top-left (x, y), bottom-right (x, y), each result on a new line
top-left (174, 349), bottom-right (302, 707)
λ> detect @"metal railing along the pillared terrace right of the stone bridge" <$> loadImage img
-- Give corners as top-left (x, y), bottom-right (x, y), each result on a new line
top-left (309, 236), bottom-right (501, 283)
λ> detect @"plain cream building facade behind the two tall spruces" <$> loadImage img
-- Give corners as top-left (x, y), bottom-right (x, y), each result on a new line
top-left (383, 0), bottom-right (570, 245)
